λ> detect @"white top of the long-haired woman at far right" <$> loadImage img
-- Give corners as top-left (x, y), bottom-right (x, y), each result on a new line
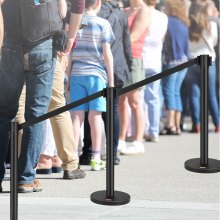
top-left (189, 21), bottom-right (218, 61)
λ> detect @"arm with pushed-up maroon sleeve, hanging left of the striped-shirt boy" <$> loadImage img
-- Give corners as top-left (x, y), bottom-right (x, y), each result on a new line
top-left (64, 0), bottom-right (85, 54)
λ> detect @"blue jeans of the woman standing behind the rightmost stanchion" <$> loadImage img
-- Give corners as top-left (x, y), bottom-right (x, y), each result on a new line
top-left (187, 62), bottom-right (220, 126)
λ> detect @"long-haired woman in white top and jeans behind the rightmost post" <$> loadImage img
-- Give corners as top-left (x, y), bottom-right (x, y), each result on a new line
top-left (187, 0), bottom-right (220, 133)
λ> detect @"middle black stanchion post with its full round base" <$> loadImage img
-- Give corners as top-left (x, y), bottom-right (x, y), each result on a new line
top-left (90, 87), bottom-right (130, 205)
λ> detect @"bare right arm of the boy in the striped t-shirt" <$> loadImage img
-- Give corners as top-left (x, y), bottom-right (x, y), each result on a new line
top-left (102, 43), bottom-right (114, 87)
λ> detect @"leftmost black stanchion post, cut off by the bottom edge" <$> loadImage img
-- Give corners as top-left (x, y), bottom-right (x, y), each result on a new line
top-left (10, 121), bottom-right (18, 220)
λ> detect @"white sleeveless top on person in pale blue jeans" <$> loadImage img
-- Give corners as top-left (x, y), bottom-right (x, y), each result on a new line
top-left (142, 9), bottom-right (168, 71)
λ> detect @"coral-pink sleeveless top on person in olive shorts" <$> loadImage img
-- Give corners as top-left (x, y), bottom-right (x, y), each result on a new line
top-left (125, 10), bottom-right (148, 59)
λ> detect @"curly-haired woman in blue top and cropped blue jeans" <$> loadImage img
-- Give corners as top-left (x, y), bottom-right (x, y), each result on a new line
top-left (160, 0), bottom-right (189, 135)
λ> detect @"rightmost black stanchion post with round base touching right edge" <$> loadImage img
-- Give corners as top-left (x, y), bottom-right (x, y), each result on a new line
top-left (185, 55), bottom-right (220, 173)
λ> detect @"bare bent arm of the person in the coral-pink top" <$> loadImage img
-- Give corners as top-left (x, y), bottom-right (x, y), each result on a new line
top-left (131, 6), bottom-right (150, 43)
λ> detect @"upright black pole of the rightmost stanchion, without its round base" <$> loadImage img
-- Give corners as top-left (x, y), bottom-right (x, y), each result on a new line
top-left (199, 55), bottom-right (210, 166)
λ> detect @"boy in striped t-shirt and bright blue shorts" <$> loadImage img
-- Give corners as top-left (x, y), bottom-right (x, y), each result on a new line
top-left (67, 0), bottom-right (115, 171)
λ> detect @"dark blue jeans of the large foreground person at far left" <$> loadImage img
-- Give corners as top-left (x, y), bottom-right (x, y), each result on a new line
top-left (0, 38), bottom-right (54, 184)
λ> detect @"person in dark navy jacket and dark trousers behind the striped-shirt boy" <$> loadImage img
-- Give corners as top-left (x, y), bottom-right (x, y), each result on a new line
top-left (80, 0), bottom-right (132, 165)
